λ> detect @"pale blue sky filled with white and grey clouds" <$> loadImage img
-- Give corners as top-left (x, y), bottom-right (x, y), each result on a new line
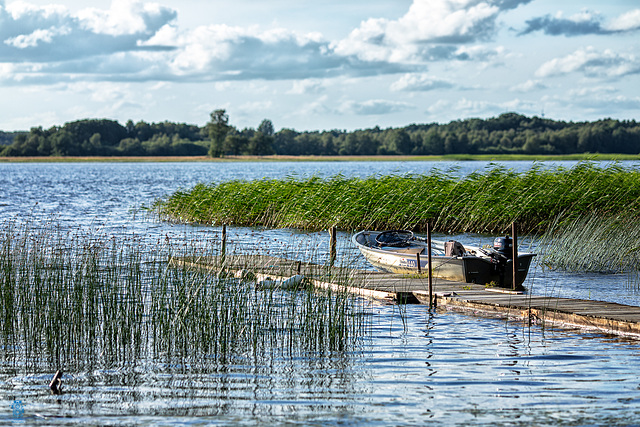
top-left (0, 0), bottom-right (640, 131)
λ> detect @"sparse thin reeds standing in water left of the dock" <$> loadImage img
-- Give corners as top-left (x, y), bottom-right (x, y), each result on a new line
top-left (0, 222), bottom-right (367, 370)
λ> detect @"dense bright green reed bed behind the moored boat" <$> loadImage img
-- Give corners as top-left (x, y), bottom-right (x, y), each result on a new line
top-left (155, 162), bottom-right (640, 234)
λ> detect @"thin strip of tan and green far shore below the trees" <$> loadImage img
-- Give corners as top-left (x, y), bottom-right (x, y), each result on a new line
top-left (0, 154), bottom-right (640, 163)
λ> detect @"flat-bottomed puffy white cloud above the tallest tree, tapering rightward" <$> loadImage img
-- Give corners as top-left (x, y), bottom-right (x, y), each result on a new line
top-left (162, 25), bottom-right (388, 80)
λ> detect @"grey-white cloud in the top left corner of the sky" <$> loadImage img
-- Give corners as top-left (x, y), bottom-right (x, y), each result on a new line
top-left (0, 0), bottom-right (176, 66)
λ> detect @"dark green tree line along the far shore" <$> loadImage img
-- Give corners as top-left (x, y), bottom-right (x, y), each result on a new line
top-left (0, 110), bottom-right (640, 157)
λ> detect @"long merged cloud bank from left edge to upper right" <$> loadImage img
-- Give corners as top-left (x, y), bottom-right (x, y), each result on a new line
top-left (0, 0), bottom-right (529, 86)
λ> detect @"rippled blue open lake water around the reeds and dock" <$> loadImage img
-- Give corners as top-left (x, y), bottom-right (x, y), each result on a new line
top-left (0, 162), bottom-right (640, 426)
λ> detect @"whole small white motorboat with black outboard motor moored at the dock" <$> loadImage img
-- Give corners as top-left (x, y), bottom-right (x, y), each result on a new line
top-left (352, 230), bottom-right (536, 289)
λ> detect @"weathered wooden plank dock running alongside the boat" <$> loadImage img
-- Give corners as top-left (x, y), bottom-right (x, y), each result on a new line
top-left (170, 255), bottom-right (640, 338)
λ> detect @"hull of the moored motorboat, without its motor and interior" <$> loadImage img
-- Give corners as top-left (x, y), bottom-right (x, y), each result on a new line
top-left (353, 232), bottom-right (535, 288)
